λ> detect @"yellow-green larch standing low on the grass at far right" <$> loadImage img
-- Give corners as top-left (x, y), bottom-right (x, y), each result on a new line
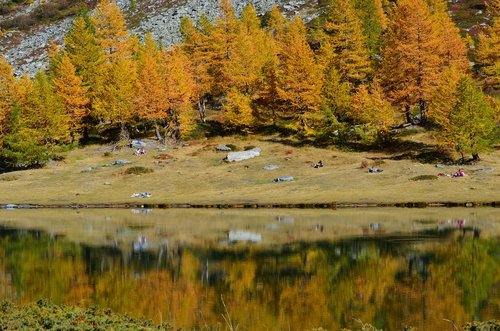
top-left (449, 76), bottom-right (499, 161)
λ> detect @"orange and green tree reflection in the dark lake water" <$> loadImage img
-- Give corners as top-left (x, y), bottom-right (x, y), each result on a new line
top-left (0, 227), bottom-right (500, 330)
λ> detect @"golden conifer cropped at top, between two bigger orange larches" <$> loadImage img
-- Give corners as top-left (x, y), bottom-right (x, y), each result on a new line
top-left (324, 0), bottom-right (371, 89)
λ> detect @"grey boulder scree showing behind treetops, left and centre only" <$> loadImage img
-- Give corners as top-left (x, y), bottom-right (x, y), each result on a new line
top-left (0, 0), bottom-right (318, 75)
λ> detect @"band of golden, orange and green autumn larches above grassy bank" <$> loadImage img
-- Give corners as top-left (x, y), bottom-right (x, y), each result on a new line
top-left (0, 0), bottom-right (500, 167)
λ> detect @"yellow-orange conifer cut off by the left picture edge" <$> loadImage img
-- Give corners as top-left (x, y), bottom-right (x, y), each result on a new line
top-left (0, 56), bottom-right (16, 137)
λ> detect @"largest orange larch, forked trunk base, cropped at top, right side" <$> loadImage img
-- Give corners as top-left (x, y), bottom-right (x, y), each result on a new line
top-left (381, 0), bottom-right (441, 122)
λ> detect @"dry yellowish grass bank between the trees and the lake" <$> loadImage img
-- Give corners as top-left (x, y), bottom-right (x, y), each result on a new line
top-left (0, 137), bottom-right (500, 204)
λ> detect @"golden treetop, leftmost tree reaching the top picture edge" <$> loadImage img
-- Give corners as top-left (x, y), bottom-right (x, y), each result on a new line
top-left (92, 0), bottom-right (132, 62)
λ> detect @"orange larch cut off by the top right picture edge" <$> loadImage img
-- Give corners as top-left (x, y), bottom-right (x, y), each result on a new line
top-left (476, 0), bottom-right (500, 90)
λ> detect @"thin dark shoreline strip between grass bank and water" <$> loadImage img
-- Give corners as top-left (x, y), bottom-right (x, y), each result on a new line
top-left (0, 201), bottom-right (500, 210)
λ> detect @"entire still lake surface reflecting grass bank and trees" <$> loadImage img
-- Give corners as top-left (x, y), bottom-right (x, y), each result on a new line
top-left (0, 208), bottom-right (500, 330)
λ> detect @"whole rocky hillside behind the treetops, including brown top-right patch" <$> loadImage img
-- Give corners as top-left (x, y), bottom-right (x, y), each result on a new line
top-left (0, 0), bottom-right (489, 75)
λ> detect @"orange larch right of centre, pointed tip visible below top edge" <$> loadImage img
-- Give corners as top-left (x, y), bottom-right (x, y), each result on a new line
top-left (276, 16), bottom-right (322, 132)
